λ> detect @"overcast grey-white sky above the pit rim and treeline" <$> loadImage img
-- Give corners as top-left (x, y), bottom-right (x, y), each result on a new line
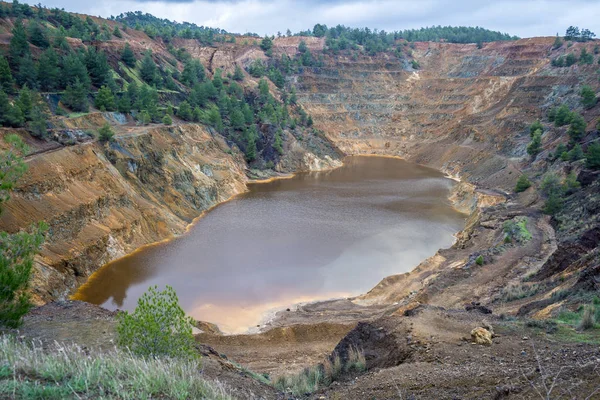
top-left (34, 0), bottom-right (600, 37)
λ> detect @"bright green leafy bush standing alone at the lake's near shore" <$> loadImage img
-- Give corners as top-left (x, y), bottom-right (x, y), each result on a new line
top-left (117, 286), bottom-right (198, 358)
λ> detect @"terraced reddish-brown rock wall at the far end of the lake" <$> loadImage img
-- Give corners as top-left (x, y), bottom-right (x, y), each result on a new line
top-left (288, 38), bottom-right (597, 191)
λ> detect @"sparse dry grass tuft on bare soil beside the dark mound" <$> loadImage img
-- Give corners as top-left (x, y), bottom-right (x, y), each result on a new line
top-left (273, 347), bottom-right (367, 396)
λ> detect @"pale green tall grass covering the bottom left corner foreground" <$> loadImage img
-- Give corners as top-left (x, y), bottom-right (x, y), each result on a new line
top-left (0, 335), bottom-right (231, 399)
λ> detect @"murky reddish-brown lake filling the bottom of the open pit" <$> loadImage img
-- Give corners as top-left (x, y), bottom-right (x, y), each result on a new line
top-left (75, 157), bottom-right (465, 333)
